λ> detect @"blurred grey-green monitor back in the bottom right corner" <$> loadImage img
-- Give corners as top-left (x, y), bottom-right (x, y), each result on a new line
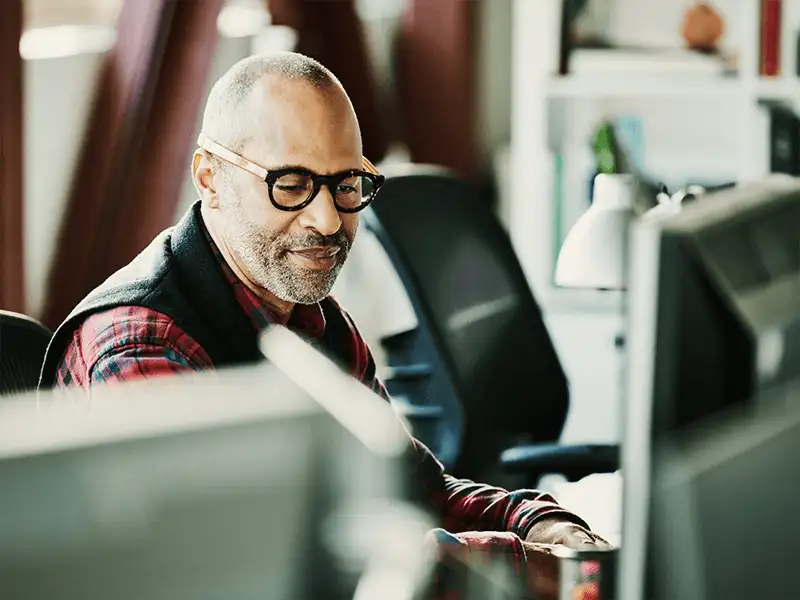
top-left (642, 385), bottom-right (800, 600)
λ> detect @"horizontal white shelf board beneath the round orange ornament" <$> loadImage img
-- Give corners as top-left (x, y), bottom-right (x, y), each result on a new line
top-left (546, 75), bottom-right (800, 99)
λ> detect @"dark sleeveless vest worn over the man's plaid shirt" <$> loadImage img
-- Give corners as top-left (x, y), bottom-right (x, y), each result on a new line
top-left (39, 202), bottom-right (352, 389)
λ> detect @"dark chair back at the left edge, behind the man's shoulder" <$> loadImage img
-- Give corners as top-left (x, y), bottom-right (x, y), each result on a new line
top-left (0, 310), bottom-right (52, 396)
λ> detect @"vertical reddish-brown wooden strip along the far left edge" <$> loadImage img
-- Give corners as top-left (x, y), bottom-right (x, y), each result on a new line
top-left (0, 0), bottom-right (25, 312)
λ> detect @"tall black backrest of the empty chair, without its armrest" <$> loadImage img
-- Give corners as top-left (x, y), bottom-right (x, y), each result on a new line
top-left (364, 167), bottom-right (569, 477)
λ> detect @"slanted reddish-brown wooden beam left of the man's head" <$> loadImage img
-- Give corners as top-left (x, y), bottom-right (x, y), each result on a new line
top-left (43, 0), bottom-right (222, 327)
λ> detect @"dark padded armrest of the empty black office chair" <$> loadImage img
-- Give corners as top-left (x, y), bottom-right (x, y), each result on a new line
top-left (500, 444), bottom-right (619, 481)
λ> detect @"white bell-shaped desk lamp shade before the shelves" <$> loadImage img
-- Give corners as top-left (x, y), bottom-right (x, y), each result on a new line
top-left (555, 175), bottom-right (636, 289)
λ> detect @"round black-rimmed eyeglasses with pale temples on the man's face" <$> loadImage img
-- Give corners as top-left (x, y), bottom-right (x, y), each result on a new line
top-left (197, 134), bottom-right (385, 213)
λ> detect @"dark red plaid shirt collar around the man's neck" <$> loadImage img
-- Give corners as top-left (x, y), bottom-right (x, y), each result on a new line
top-left (200, 218), bottom-right (325, 339)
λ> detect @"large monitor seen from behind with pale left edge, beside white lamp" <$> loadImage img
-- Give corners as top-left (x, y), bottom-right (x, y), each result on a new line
top-left (619, 177), bottom-right (800, 600)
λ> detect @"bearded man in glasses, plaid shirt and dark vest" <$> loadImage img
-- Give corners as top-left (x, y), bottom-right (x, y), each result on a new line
top-left (41, 53), bottom-right (606, 600)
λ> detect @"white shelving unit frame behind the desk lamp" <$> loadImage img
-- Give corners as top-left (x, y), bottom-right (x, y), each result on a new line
top-left (509, 0), bottom-right (800, 312)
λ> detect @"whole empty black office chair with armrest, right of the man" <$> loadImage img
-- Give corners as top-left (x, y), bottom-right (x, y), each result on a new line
top-left (364, 166), bottom-right (619, 485)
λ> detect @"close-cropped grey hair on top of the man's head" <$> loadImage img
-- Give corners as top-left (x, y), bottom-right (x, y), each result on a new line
top-left (202, 52), bottom-right (349, 152)
